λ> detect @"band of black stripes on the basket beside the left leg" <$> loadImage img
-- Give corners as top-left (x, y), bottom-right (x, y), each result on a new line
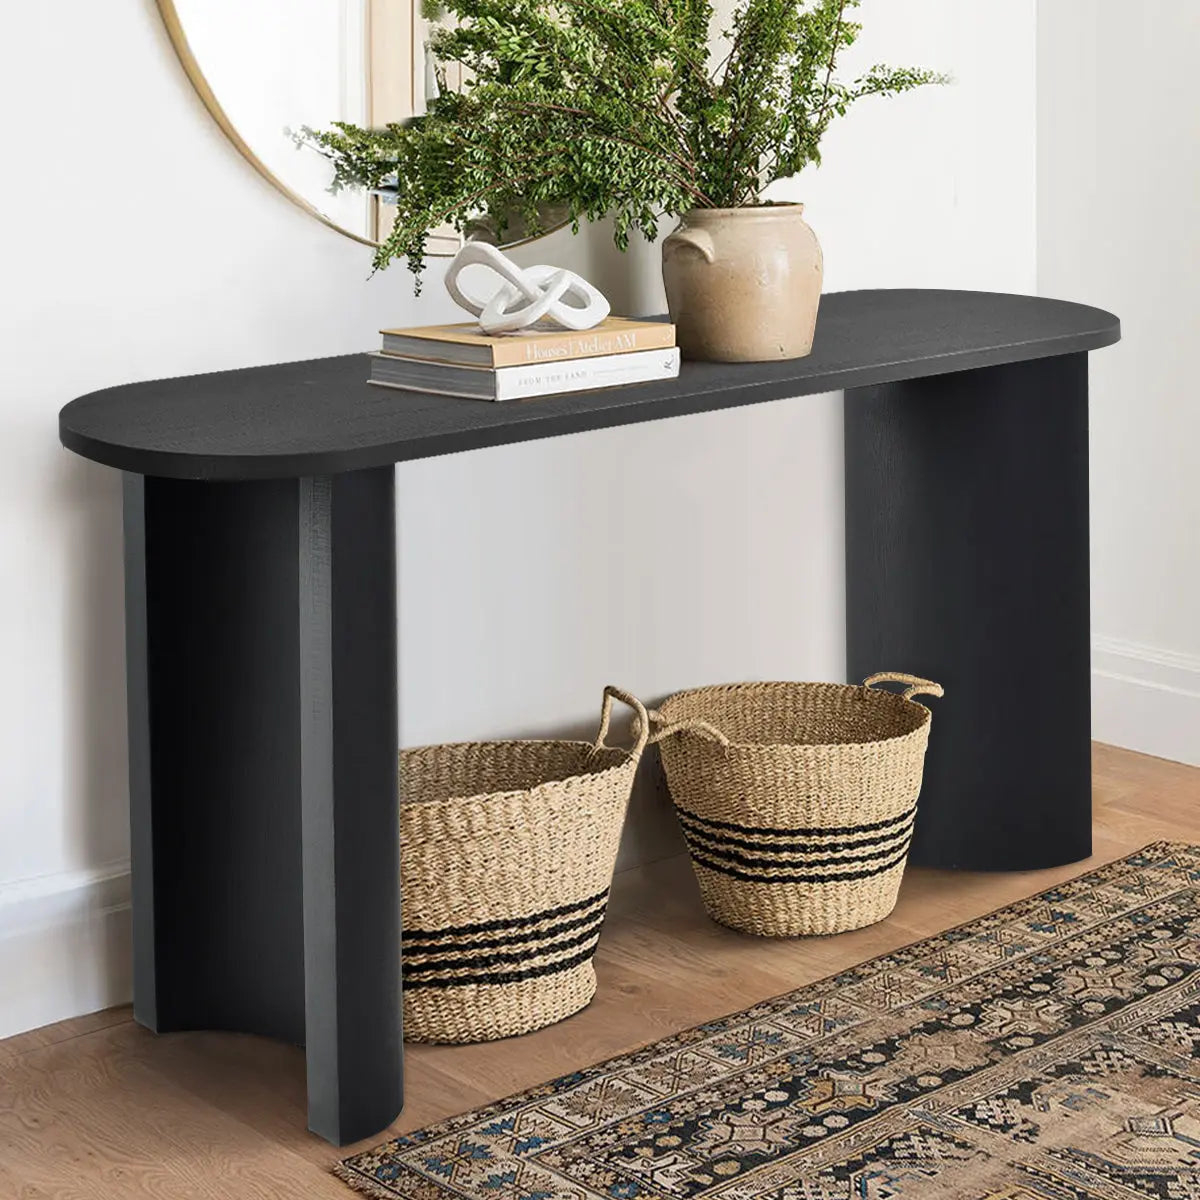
top-left (402, 888), bottom-right (608, 989)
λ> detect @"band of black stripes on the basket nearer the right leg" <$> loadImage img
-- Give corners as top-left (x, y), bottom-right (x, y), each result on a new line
top-left (676, 805), bottom-right (917, 883)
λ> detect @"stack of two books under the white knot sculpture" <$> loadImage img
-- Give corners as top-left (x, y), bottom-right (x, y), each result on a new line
top-left (371, 317), bottom-right (679, 400)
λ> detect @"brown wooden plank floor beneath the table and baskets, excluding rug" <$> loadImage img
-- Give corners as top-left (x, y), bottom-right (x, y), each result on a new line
top-left (0, 745), bottom-right (1200, 1200)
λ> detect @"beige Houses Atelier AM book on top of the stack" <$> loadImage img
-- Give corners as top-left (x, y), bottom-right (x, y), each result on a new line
top-left (382, 317), bottom-right (674, 368)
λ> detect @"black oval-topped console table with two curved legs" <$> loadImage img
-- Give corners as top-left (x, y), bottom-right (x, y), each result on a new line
top-left (60, 290), bottom-right (1121, 1144)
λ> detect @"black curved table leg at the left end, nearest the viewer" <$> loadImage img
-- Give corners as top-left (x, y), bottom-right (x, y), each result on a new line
top-left (125, 467), bottom-right (403, 1144)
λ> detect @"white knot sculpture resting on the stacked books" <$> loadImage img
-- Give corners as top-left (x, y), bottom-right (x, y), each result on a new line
top-left (446, 241), bottom-right (610, 334)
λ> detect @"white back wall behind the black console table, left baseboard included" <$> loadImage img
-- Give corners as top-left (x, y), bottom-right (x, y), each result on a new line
top-left (0, 0), bottom-right (1034, 1034)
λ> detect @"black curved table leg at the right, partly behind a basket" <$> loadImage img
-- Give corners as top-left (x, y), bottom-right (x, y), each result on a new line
top-left (845, 354), bottom-right (1092, 870)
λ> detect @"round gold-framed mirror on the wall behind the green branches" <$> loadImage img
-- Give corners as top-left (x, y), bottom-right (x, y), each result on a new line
top-left (157, 0), bottom-right (472, 254)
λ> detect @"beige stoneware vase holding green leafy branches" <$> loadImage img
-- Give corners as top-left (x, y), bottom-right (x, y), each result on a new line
top-left (662, 204), bottom-right (822, 362)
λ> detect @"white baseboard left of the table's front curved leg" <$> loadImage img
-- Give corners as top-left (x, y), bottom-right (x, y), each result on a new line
top-left (0, 863), bottom-right (133, 1038)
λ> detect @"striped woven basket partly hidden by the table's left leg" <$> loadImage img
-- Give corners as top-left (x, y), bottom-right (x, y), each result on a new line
top-left (400, 688), bottom-right (649, 1042)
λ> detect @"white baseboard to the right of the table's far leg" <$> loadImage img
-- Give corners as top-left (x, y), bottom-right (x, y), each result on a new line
top-left (1092, 637), bottom-right (1200, 767)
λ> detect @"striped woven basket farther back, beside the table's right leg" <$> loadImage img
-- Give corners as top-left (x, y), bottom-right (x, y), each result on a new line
top-left (650, 672), bottom-right (942, 937)
